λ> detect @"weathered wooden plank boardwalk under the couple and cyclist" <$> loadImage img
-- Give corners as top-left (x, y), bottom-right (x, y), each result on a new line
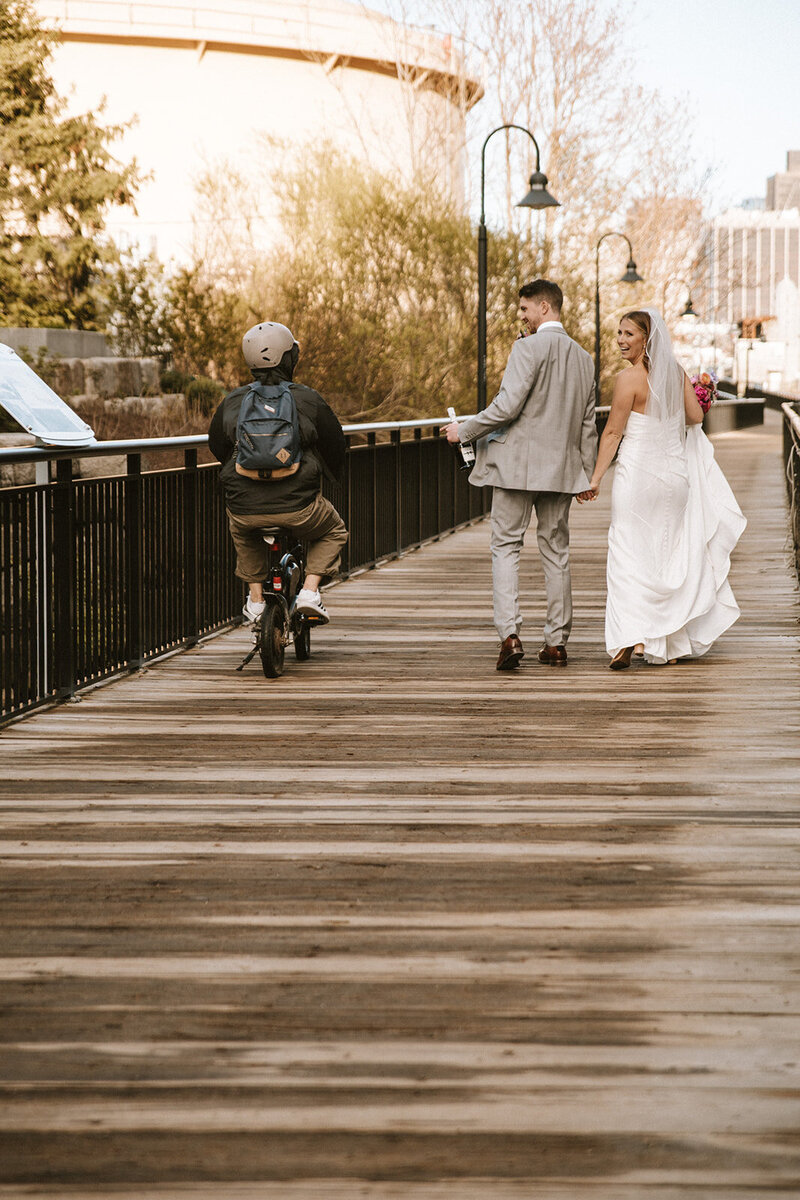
top-left (0, 416), bottom-right (800, 1200)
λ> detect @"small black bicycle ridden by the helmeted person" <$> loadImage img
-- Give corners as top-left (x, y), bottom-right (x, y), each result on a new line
top-left (236, 529), bottom-right (320, 679)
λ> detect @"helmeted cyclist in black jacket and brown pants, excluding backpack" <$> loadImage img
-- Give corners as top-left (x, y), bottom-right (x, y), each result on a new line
top-left (209, 320), bottom-right (348, 623)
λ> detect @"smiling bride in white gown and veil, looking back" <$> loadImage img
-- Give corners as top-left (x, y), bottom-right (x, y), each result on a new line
top-left (578, 308), bottom-right (746, 671)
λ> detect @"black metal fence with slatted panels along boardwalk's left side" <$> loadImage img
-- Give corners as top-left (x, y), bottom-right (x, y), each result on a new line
top-left (0, 421), bottom-right (488, 724)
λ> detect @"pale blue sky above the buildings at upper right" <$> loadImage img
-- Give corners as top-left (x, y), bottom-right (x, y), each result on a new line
top-left (367, 0), bottom-right (800, 212)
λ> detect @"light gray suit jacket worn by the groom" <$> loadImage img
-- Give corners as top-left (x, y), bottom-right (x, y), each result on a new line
top-left (458, 325), bottom-right (597, 494)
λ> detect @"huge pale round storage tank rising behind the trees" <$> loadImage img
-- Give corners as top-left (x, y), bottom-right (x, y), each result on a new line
top-left (36, 0), bottom-right (482, 259)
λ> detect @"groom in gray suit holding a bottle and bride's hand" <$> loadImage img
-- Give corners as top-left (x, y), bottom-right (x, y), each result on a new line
top-left (444, 280), bottom-right (597, 671)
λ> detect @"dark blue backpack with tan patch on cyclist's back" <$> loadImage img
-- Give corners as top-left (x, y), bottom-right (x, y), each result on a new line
top-left (236, 382), bottom-right (302, 479)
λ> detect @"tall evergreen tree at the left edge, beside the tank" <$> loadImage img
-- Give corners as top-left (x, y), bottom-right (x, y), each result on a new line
top-left (0, 0), bottom-right (142, 329)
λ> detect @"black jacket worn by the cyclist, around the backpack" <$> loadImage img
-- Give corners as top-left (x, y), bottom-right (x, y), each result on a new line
top-left (209, 367), bottom-right (345, 516)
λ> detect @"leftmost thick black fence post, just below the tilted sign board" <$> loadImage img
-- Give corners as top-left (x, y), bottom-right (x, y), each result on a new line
top-left (50, 458), bottom-right (77, 700)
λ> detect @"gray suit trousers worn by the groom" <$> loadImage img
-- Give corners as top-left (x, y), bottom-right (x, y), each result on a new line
top-left (492, 487), bottom-right (572, 646)
